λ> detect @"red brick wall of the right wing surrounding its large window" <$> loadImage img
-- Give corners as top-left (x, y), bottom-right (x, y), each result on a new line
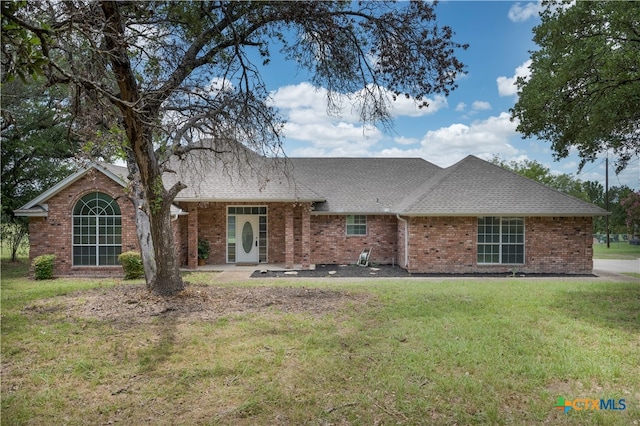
top-left (398, 217), bottom-right (593, 274)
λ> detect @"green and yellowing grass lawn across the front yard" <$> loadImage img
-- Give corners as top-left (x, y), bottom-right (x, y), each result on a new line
top-left (1, 263), bottom-right (640, 426)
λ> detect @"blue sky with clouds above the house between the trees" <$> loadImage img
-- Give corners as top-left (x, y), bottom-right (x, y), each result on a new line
top-left (256, 1), bottom-right (640, 189)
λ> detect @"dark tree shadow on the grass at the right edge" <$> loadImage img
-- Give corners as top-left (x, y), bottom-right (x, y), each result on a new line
top-left (554, 283), bottom-right (640, 332)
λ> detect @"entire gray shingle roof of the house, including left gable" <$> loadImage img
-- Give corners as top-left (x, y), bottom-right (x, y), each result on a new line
top-left (16, 150), bottom-right (608, 216)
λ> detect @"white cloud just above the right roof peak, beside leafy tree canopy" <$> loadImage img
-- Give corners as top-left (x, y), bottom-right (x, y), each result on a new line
top-left (376, 112), bottom-right (522, 167)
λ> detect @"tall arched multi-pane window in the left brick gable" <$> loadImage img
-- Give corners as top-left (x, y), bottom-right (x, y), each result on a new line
top-left (73, 192), bottom-right (122, 266)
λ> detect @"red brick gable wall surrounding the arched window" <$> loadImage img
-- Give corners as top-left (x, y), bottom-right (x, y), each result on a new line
top-left (29, 171), bottom-right (139, 276)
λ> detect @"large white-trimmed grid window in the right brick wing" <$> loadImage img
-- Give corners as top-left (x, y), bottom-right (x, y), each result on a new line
top-left (478, 216), bottom-right (524, 265)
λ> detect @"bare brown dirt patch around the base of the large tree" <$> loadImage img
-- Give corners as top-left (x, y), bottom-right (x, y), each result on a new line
top-left (25, 284), bottom-right (373, 324)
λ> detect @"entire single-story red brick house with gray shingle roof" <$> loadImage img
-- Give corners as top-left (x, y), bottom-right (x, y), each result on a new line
top-left (16, 154), bottom-right (607, 275)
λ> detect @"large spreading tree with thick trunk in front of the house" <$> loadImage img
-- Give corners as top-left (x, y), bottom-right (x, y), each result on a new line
top-left (2, 1), bottom-right (466, 294)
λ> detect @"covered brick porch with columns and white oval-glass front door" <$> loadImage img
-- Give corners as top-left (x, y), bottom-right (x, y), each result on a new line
top-left (177, 201), bottom-right (312, 271)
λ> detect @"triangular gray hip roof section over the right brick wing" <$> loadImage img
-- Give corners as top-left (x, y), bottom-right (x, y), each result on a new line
top-left (397, 155), bottom-right (607, 216)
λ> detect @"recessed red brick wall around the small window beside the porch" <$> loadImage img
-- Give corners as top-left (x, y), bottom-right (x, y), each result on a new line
top-left (311, 215), bottom-right (398, 265)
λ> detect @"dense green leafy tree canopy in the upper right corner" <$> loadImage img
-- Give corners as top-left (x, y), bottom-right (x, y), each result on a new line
top-left (511, 0), bottom-right (640, 171)
